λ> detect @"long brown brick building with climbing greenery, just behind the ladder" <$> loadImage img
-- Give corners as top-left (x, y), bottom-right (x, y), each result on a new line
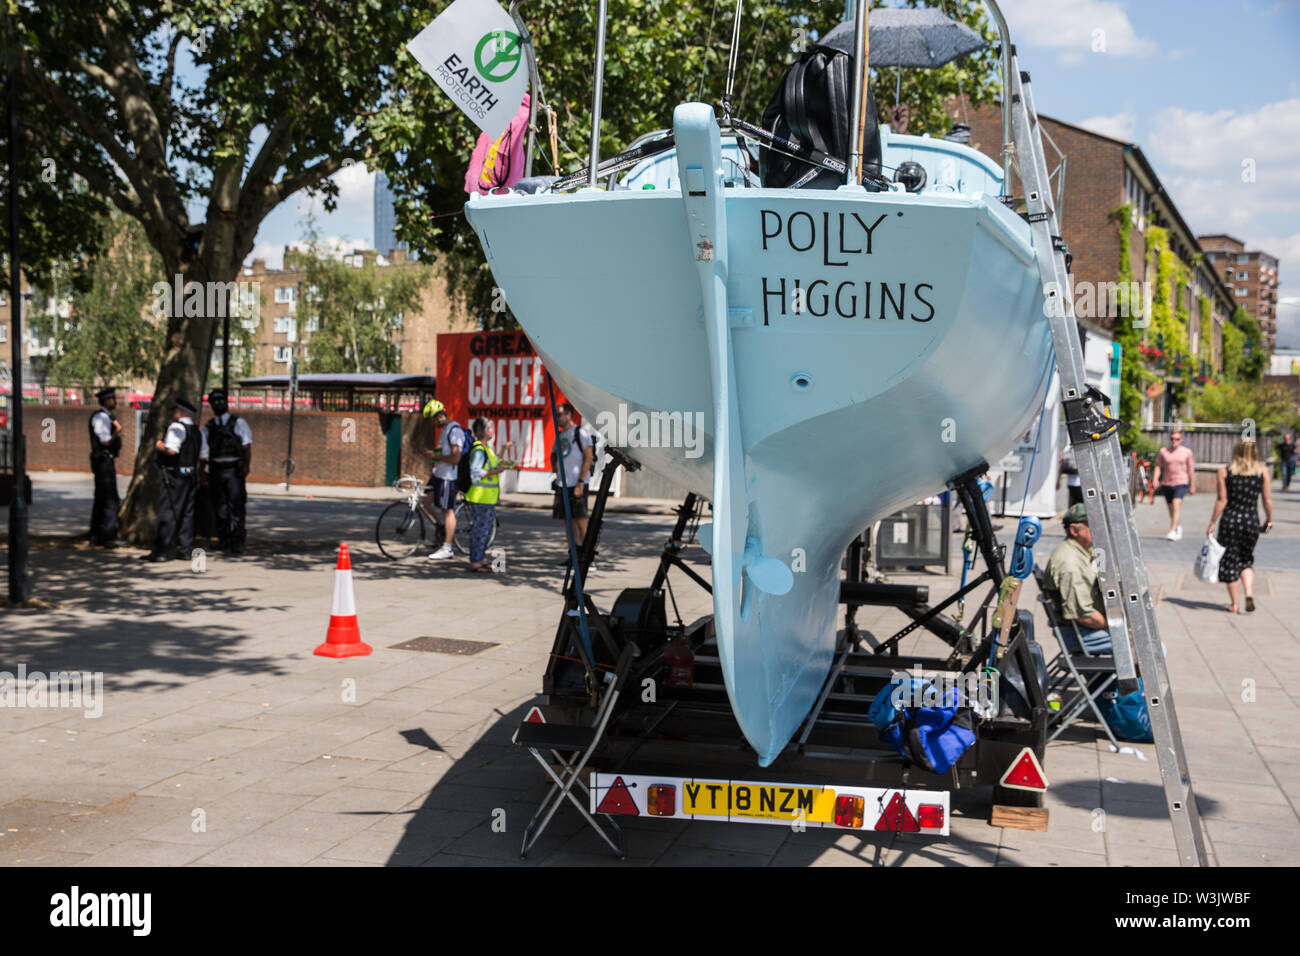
top-left (954, 104), bottom-right (1235, 424)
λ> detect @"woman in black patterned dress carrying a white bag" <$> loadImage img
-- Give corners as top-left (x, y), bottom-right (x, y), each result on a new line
top-left (1206, 441), bottom-right (1273, 614)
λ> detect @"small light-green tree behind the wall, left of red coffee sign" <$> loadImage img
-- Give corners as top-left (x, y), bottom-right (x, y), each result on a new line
top-left (298, 239), bottom-right (432, 372)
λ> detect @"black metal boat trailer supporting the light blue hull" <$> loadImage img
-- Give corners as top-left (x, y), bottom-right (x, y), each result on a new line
top-left (542, 447), bottom-right (1049, 832)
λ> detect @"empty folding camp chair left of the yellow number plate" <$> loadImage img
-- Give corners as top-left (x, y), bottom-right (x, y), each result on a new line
top-left (514, 641), bottom-right (641, 860)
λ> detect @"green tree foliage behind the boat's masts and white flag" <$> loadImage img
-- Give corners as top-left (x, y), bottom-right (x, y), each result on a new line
top-left (369, 0), bottom-right (1000, 326)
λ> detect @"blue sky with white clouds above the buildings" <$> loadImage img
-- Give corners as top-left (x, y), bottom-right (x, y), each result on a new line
top-left (241, 0), bottom-right (1300, 346)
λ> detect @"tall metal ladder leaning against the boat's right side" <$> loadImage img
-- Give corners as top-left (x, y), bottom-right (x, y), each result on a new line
top-left (1004, 52), bottom-right (1206, 866)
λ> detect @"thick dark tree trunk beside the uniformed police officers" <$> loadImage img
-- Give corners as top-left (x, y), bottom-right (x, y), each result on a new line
top-left (121, 259), bottom-right (223, 546)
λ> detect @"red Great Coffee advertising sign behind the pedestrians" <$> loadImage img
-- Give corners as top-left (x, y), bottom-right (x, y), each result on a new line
top-left (438, 332), bottom-right (566, 471)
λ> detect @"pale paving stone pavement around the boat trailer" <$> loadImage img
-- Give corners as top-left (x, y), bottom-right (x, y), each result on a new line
top-left (0, 485), bottom-right (1300, 866)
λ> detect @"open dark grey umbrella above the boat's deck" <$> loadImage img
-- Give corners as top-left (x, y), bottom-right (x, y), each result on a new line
top-left (818, 9), bottom-right (988, 104)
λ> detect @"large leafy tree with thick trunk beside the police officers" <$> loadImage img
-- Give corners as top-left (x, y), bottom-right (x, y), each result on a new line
top-left (5, 0), bottom-right (442, 541)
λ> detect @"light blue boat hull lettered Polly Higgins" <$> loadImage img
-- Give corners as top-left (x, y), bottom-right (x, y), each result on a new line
top-left (467, 104), bottom-right (1050, 766)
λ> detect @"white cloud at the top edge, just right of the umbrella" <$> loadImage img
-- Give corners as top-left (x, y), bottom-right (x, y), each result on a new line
top-left (1002, 0), bottom-right (1160, 66)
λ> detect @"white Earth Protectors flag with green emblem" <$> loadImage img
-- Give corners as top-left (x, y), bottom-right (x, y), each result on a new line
top-left (407, 0), bottom-right (528, 139)
